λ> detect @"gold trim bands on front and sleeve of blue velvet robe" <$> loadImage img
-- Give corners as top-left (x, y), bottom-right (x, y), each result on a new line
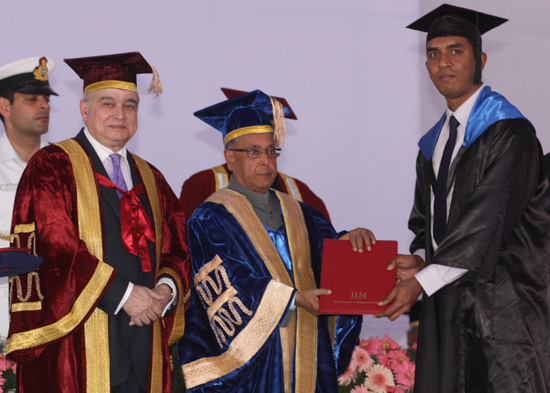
top-left (183, 189), bottom-right (317, 393)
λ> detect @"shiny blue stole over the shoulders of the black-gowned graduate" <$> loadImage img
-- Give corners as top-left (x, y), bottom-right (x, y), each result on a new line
top-left (418, 86), bottom-right (535, 161)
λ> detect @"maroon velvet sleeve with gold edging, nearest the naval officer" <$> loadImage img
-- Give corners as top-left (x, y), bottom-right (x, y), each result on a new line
top-left (10, 145), bottom-right (114, 361)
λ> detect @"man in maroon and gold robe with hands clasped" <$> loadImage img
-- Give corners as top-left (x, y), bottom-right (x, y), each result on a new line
top-left (7, 52), bottom-right (189, 393)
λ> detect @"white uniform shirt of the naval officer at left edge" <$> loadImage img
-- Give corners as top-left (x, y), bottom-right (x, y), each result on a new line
top-left (0, 133), bottom-right (46, 337)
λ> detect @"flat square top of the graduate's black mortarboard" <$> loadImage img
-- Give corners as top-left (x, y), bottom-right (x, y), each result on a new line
top-left (407, 4), bottom-right (508, 34)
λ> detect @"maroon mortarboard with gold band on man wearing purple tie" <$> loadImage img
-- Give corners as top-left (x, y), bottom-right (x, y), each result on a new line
top-left (65, 52), bottom-right (162, 96)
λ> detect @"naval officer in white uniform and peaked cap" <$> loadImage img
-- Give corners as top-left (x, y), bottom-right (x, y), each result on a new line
top-left (0, 56), bottom-right (57, 338)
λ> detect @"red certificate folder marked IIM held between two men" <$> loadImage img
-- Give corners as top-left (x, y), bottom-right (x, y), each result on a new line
top-left (319, 239), bottom-right (397, 315)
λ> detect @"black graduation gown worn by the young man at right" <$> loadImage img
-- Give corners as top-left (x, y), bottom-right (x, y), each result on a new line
top-left (409, 119), bottom-right (550, 393)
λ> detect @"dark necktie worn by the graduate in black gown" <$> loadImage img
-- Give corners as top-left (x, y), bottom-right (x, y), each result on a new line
top-left (433, 116), bottom-right (459, 244)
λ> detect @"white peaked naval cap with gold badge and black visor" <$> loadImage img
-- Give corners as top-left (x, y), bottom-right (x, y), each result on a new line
top-left (0, 56), bottom-right (58, 95)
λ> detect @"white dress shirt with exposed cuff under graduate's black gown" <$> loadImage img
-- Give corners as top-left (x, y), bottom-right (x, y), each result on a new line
top-left (415, 85), bottom-right (483, 296)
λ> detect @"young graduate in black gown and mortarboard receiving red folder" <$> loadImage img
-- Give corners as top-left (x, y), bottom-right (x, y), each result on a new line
top-left (378, 5), bottom-right (550, 393)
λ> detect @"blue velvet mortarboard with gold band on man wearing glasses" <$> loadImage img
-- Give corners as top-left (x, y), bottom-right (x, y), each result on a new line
top-left (194, 90), bottom-right (291, 146)
